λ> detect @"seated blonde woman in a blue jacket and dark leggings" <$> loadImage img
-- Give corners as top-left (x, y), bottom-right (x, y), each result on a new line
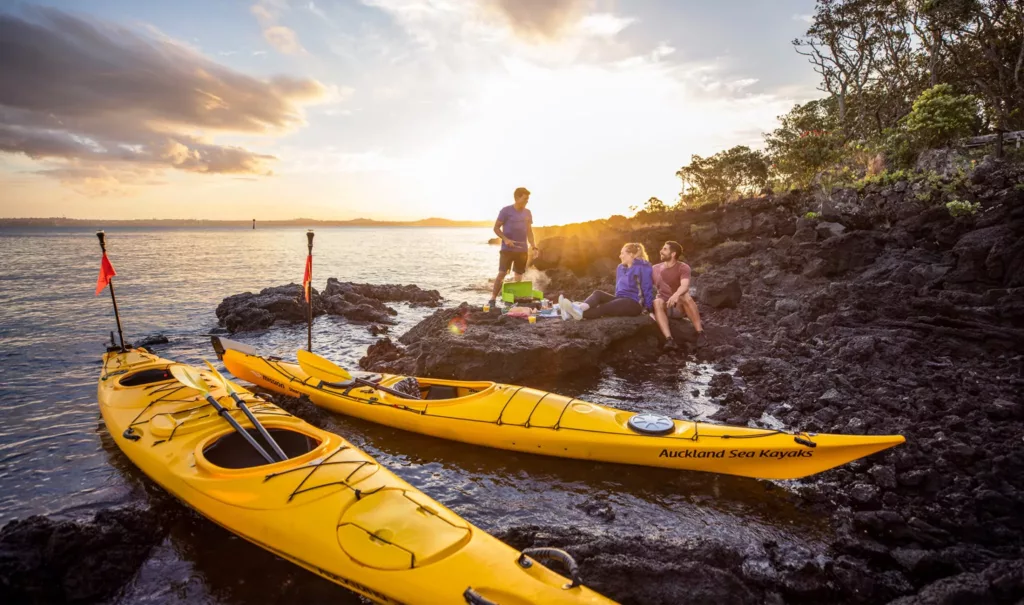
top-left (558, 243), bottom-right (656, 319)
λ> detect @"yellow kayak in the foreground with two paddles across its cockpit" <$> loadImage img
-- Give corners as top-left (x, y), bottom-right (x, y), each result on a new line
top-left (98, 348), bottom-right (613, 605)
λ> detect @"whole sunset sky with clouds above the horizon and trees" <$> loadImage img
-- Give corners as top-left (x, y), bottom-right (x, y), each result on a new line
top-left (0, 0), bottom-right (821, 225)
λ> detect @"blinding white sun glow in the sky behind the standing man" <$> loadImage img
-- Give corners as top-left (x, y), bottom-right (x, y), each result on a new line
top-left (413, 56), bottom-right (784, 224)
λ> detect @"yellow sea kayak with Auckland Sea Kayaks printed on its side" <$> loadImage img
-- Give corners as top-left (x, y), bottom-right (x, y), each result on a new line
top-left (214, 337), bottom-right (904, 479)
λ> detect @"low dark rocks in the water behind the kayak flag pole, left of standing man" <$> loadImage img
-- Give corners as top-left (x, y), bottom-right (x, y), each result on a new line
top-left (216, 277), bottom-right (441, 333)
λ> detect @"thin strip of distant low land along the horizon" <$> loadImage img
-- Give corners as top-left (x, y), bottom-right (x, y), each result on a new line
top-left (0, 218), bottom-right (494, 229)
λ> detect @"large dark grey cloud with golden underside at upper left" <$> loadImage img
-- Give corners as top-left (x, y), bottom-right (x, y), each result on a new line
top-left (0, 8), bottom-right (327, 190)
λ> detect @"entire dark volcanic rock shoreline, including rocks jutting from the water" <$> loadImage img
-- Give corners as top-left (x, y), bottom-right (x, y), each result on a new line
top-left (0, 161), bottom-right (1024, 605)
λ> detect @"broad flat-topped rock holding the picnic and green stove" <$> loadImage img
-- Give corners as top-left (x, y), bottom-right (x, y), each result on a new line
top-left (359, 303), bottom-right (694, 383)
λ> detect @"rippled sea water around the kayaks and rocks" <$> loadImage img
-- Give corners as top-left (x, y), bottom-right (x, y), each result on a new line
top-left (0, 227), bottom-right (822, 603)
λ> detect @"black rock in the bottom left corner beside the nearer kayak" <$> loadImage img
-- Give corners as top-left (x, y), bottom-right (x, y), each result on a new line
top-left (0, 508), bottom-right (167, 603)
